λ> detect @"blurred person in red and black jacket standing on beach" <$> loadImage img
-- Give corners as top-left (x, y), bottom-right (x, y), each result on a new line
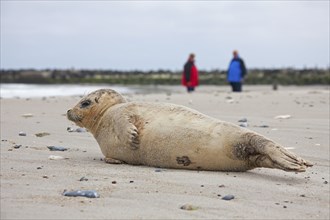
top-left (181, 53), bottom-right (198, 92)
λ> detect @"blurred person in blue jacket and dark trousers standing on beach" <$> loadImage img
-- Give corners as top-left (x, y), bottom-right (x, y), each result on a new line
top-left (227, 50), bottom-right (247, 92)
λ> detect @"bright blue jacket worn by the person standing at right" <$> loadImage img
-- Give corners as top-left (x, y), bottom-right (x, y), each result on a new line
top-left (227, 57), bottom-right (246, 82)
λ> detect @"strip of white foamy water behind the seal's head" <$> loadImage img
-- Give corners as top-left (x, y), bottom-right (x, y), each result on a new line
top-left (0, 83), bottom-right (179, 99)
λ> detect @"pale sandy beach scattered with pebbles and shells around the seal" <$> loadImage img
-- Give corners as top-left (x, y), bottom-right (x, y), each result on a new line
top-left (0, 86), bottom-right (330, 219)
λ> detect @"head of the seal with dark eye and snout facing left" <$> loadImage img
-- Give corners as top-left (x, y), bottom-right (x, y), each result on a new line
top-left (67, 89), bottom-right (126, 129)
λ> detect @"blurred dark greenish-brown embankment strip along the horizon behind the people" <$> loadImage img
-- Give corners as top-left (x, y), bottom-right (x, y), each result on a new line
top-left (0, 68), bottom-right (330, 85)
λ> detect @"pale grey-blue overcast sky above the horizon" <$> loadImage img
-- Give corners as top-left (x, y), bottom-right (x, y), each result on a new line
top-left (0, 0), bottom-right (330, 71)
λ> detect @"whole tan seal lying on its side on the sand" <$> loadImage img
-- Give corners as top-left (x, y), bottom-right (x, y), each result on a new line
top-left (67, 89), bottom-right (312, 172)
